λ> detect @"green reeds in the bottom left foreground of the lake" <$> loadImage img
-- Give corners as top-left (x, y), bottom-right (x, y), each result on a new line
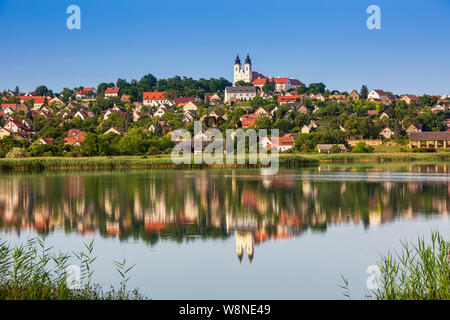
top-left (0, 238), bottom-right (145, 300)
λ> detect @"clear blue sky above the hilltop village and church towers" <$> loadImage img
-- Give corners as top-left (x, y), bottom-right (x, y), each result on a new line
top-left (0, 0), bottom-right (450, 94)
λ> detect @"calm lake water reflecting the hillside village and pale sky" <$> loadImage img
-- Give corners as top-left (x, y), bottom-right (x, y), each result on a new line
top-left (0, 165), bottom-right (450, 299)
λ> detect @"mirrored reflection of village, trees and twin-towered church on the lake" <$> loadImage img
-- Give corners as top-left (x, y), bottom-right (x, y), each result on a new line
top-left (0, 165), bottom-right (450, 262)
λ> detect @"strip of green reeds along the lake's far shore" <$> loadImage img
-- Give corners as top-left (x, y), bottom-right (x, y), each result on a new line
top-left (0, 152), bottom-right (450, 171)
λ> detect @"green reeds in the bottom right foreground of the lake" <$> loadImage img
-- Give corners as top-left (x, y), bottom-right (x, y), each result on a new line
top-left (341, 231), bottom-right (450, 300)
